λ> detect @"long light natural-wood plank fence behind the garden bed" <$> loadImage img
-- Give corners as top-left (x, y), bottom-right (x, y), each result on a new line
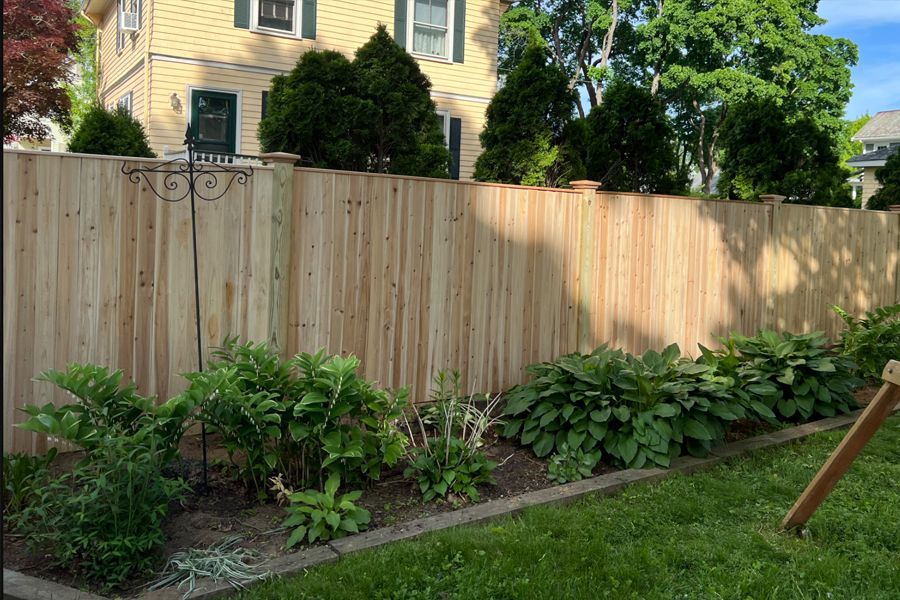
top-left (3, 151), bottom-right (900, 451)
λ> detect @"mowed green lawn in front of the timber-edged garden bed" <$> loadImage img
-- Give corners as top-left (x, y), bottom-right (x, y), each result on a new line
top-left (240, 416), bottom-right (900, 600)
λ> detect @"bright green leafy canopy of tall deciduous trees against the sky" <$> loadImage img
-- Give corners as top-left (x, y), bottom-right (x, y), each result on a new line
top-left (501, 0), bottom-right (857, 193)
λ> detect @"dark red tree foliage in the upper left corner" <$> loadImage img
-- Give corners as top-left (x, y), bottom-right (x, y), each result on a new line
top-left (3, 0), bottom-right (77, 141)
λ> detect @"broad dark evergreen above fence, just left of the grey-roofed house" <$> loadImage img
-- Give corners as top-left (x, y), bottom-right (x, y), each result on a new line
top-left (719, 100), bottom-right (852, 207)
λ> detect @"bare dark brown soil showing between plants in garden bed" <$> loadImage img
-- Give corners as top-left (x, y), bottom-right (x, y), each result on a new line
top-left (3, 386), bottom-right (878, 597)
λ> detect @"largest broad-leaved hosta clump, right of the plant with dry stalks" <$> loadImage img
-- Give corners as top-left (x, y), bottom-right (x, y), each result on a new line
top-left (503, 344), bottom-right (747, 468)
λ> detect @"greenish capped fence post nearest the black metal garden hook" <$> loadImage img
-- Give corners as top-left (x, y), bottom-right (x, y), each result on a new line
top-left (259, 152), bottom-right (300, 356)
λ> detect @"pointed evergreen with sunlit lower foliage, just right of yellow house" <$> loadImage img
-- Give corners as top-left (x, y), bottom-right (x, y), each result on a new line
top-left (475, 43), bottom-right (575, 187)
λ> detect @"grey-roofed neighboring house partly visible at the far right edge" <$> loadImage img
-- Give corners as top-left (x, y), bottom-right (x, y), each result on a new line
top-left (847, 110), bottom-right (900, 208)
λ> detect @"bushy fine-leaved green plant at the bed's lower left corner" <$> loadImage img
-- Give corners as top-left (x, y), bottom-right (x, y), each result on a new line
top-left (18, 429), bottom-right (187, 589)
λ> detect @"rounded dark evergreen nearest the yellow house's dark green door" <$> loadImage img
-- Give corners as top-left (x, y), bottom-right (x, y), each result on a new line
top-left (258, 50), bottom-right (373, 171)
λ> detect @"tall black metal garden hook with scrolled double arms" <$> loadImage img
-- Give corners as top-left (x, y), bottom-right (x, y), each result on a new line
top-left (122, 125), bottom-right (253, 491)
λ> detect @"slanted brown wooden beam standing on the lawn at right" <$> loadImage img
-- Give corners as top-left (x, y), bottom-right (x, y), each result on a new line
top-left (781, 360), bottom-right (900, 529)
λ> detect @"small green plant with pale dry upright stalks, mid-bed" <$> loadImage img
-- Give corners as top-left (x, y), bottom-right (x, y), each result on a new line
top-left (404, 386), bottom-right (500, 502)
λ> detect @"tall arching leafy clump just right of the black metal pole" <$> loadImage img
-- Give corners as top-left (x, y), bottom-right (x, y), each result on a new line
top-left (198, 338), bottom-right (407, 496)
